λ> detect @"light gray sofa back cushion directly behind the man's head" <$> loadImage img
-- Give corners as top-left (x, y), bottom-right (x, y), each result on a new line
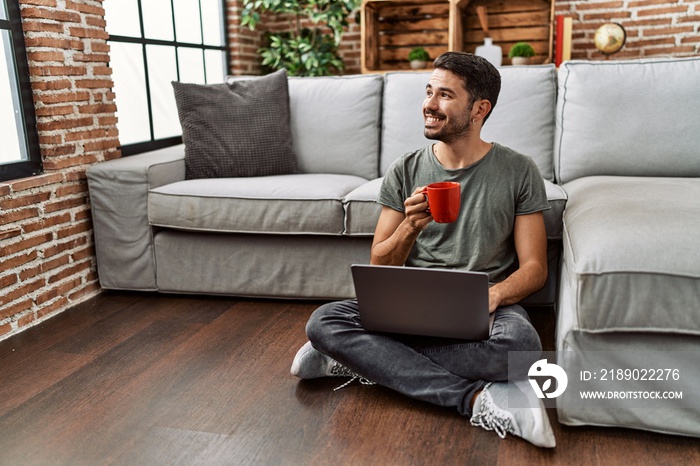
top-left (380, 65), bottom-right (557, 180)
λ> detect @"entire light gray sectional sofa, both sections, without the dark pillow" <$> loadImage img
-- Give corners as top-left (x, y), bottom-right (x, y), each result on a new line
top-left (88, 58), bottom-right (700, 436)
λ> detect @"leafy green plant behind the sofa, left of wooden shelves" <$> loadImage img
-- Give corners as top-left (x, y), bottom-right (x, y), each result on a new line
top-left (241, 0), bottom-right (361, 76)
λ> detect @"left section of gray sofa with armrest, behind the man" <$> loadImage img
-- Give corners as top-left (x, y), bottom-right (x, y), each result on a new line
top-left (87, 66), bottom-right (566, 304)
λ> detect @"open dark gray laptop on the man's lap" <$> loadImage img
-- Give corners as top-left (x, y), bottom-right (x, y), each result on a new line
top-left (351, 264), bottom-right (493, 340)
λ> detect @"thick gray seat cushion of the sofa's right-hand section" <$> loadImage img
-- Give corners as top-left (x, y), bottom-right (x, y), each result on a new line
top-left (563, 176), bottom-right (700, 334)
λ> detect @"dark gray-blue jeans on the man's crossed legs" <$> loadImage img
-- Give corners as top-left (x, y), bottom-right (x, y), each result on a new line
top-left (306, 300), bottom-right (542, 416)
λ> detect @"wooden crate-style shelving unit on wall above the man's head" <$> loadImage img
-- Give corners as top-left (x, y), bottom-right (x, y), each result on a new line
top-left (361, 0), bottom-right (554, 73)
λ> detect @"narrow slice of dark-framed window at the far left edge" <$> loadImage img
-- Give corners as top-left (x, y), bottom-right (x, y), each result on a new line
top-left (0, 0), bottom-right (41, 181)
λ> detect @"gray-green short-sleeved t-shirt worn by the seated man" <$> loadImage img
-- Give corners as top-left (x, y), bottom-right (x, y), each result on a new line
top-left (377, 143), bottom-right (549, 283)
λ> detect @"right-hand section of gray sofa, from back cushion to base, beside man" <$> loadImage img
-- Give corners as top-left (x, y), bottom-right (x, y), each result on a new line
top-left (554, 58), bottom-right (700, 436)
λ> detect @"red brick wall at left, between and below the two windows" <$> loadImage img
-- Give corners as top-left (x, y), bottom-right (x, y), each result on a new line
top-left (0, 0), bottom-right (120, 338)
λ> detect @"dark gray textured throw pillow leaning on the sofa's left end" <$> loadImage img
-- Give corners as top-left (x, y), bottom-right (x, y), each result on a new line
top-left (172, 70), bottom-right (297, 179)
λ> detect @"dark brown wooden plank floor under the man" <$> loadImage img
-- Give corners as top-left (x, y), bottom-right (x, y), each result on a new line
top-left (0, 293), bottom-right (700, 466)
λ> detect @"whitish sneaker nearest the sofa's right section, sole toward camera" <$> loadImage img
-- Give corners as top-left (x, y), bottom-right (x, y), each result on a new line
top-left (470, 382), bottom-right (556, 448)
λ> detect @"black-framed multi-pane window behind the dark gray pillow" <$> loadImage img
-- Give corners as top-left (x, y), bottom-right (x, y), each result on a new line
top-left (103, 0), bottom-right (228, 155)
